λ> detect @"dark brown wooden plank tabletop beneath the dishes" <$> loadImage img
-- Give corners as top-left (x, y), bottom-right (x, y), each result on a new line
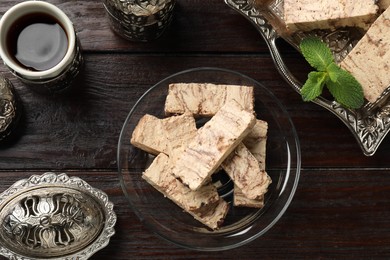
top-left (0, 0), bottom-right (390, 259)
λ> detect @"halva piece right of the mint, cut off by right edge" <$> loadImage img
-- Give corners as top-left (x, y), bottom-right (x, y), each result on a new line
top-left (340, 8), bottom-right (390, 103)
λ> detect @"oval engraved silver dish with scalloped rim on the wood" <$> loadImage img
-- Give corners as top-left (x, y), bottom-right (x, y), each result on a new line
top-left (0, 172), bottom-right (116, 259)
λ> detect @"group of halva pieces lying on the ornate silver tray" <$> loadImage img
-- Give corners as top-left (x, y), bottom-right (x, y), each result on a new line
top-left (283, 0), bottom-right (390, 103)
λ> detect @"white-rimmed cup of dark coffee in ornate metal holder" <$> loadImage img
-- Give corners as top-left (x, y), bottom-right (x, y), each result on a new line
top-left (0, 1), bottom-right (83, 93)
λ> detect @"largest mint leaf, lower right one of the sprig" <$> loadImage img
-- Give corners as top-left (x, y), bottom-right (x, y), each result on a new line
top-left (326, 64), bottom-right (364, 108)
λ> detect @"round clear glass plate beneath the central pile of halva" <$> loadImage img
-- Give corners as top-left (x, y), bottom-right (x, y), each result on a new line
top-left (118, 68), bottom-right (301, 251)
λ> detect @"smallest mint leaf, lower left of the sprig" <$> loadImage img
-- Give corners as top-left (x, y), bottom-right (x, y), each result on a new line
top-left (301, 71), bottom-right (327, 101)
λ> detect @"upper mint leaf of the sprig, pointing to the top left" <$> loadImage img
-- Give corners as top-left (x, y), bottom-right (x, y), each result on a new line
top-left (299, 37), bottom-right (334, 71)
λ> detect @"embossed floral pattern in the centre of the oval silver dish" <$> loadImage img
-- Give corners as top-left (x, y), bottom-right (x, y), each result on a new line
top-left (3, 193), bottom-right (85, 248)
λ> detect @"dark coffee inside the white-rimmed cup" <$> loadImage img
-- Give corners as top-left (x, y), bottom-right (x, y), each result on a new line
top-left (7, 13), bottom-right (68, 71)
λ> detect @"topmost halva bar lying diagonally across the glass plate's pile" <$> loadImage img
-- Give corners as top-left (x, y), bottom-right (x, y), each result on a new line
top-left (173, 100), bottom-right (256, 190)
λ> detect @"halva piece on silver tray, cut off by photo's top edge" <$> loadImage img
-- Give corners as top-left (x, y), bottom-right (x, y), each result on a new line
top-left (283, 0), bottom-right (378, 33)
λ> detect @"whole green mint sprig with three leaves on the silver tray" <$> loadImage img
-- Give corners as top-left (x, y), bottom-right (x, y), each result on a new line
top-left (299, 37), bottom-right (364, 108)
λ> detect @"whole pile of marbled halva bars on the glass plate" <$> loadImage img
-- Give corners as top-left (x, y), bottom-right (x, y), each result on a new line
top-left (131, 83), bottom-right (271, 229)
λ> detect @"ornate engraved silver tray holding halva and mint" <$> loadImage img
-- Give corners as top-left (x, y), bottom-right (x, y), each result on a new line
top-left (225, 0), bottom-right (390, 156)
